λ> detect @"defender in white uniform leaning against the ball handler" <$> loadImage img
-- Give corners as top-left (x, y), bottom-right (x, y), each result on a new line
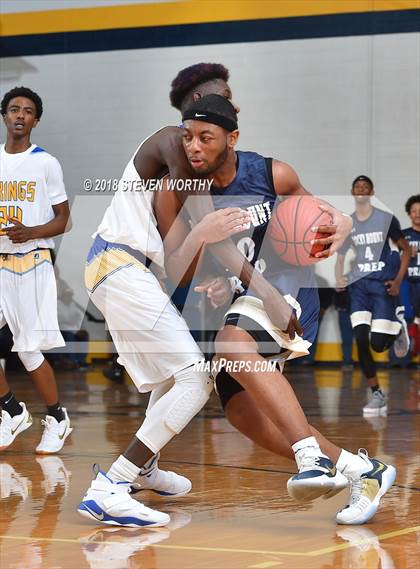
top-left (78, 64), bottom-right (351, 526)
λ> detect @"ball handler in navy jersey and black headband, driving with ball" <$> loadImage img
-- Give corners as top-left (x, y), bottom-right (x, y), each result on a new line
top-left (155, 95), bottom-right (395, 524)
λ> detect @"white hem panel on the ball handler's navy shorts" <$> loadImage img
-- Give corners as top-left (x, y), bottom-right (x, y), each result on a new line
top-left (225, 296), bottom-right (311, 361)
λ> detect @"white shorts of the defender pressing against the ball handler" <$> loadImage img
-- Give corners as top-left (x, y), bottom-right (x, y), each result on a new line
top-left (86, 251), bottom-right (203, 393)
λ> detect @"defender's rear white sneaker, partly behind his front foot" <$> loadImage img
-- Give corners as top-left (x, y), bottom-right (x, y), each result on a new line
top-left (131, 453), bottom-right (192, 498)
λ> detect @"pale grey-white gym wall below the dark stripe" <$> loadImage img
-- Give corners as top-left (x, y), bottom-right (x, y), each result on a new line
top-left (0, 32), bottom-right (420, 338)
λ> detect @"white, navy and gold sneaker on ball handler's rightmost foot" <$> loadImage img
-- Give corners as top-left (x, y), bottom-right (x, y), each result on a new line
top-left (335, 451), bottom-right (397, 525)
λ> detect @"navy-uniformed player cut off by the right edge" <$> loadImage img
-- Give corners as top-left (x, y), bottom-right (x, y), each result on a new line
top-left (403, 194), bottom-right (420, 325)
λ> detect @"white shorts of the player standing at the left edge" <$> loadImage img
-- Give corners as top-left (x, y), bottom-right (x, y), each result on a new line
top-left (0, 249), bottom-right (65, 352)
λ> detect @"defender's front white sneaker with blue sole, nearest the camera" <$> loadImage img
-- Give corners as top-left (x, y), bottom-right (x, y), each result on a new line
top-left (77, 471), bottom-right (171, 527)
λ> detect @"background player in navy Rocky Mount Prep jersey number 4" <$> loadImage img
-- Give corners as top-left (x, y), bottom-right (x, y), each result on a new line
top-left (336, 176), bottom-right (410, 416)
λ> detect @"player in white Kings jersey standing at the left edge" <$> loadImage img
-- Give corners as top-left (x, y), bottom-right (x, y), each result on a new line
top-left (0, 87), bottom-right (72, 454)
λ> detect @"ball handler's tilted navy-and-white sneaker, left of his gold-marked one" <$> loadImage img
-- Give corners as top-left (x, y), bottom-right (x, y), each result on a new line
top-left (287, 447), bottom-right (349, 502)
